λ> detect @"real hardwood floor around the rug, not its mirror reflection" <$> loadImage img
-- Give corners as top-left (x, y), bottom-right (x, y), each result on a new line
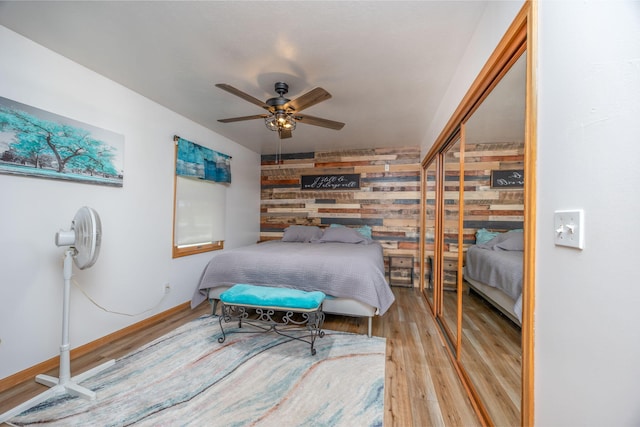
top-left (0, 287), bottom-right (480, 427)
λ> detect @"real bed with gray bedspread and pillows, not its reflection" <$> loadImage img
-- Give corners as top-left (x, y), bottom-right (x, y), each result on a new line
top-left (191, 226), bottom-right (395, 336)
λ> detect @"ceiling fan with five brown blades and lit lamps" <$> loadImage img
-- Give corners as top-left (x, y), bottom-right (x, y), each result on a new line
top-left (216, 82), bottom-right (344, 139)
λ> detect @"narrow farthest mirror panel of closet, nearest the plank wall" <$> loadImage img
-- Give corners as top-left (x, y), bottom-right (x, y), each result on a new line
top-left (423, 159), bottom-right (437, 309)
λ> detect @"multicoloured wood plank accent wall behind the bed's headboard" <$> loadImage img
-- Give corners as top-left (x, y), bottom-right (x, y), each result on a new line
top-left (260, 146), bottom-right (421, 286)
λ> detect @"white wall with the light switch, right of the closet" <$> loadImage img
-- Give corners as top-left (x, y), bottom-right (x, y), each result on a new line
top-left (535, 1), bottom-right (640, 426)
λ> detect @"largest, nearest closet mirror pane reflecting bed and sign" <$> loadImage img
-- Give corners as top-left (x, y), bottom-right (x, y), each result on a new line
top-left (460, 54), bottom-right (526, 425)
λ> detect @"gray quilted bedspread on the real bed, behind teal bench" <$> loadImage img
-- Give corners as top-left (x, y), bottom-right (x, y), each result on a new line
top-left (191, 240), bottom-right (395, 315)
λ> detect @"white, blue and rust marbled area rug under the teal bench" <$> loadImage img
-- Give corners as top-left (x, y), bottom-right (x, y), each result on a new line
top-left (9, 316), bottom-right (386, 427)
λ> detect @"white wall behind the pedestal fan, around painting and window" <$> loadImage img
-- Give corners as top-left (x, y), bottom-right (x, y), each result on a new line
top-left (0, 26), bottom-right (260, 378)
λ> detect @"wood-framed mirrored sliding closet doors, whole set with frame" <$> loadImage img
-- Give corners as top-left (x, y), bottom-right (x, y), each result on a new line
top-left (421, 3), bottom-right (535, 425)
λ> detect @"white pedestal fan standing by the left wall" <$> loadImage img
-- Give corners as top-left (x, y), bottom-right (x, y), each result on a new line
top-left (0, 206), bottom-right (115, 423)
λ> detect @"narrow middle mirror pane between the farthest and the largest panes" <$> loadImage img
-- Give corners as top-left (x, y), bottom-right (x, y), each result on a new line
top-left (439, 138), bottom-right (461, 343)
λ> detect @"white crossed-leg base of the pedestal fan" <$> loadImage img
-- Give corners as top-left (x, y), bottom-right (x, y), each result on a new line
top-left (0, 360), bottom-right (116, 423)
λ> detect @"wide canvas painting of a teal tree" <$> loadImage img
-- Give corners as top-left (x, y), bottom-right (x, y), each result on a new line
top-left (0, 97), bottom-right (124, 187)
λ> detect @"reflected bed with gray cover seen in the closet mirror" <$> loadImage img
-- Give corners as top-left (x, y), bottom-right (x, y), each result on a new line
top-left (463, 230), bottom-right (524, 325)
